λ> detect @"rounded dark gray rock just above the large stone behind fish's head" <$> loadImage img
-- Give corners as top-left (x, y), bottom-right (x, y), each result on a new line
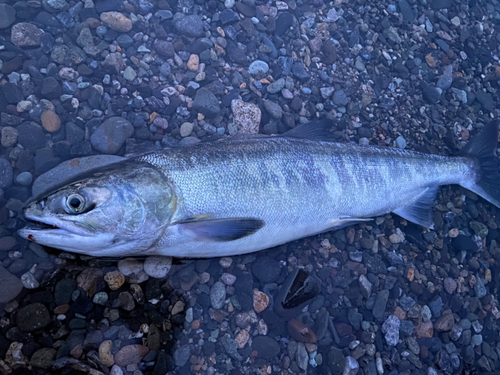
top-left (90, 116), bottom-right (134, 154)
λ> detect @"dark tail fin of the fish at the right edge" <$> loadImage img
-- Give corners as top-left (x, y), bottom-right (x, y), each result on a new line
top-left (460, 120), bottom-right (500, 207)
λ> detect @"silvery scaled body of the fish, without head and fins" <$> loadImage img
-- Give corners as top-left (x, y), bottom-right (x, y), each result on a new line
top-left (139, 138), bottom-right (473, 256)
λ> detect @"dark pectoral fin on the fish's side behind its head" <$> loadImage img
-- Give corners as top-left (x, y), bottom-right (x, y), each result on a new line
top-left (176, 218), bottom-right (265, 242)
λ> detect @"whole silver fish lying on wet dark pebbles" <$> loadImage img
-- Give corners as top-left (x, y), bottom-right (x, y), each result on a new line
top-left (19, 120), bottom-right (500, 258)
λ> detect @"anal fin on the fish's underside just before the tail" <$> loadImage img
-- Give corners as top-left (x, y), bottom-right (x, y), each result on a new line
top-left (393, 186), bottom-right (439, 229)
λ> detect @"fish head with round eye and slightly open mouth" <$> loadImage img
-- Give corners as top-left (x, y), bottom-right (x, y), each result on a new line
top-left (19, 162), bottom-right (176, 256)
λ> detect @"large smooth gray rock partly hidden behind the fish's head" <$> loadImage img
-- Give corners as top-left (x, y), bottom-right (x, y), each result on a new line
top-left (32, 155), bottom-right (125, 196)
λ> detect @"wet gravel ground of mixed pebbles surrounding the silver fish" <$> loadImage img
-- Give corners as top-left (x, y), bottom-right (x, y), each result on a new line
top-left (0, 0), bottom-right (500, 375)
